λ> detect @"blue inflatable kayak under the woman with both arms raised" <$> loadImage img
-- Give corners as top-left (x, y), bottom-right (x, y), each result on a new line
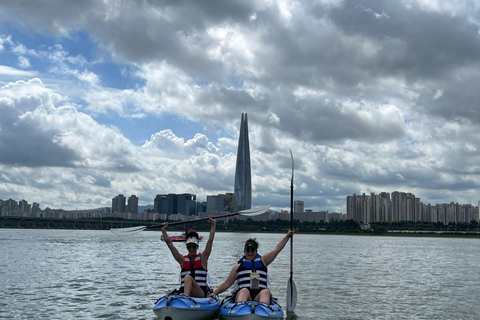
top-left (153, 293), bottom-right (220, 320)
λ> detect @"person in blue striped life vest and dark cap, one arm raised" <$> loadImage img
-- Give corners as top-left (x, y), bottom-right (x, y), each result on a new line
top-left (208, 229), bottom-right (295, 304)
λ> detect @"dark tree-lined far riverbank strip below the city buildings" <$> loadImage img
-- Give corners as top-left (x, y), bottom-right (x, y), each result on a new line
top-left (0, 216), bottom-right (480, 238)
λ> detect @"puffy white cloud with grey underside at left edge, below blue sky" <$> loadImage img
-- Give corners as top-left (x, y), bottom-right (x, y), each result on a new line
top-left (0, 78), bottom-right (140, 172)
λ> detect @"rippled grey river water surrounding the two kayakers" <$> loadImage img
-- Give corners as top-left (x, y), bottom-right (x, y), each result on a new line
top-left (0, 229), bottom-right (480, 320)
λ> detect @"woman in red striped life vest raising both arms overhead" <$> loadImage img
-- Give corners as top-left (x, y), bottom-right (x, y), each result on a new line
top-left (162, 216), bottom-right (217, 298)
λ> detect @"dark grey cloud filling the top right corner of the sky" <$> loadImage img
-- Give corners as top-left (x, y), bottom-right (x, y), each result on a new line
top-left (329, 1), bottom-right (480, 121)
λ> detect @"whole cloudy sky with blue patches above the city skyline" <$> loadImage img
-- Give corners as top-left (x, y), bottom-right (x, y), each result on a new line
top-left (0, 0), bottom-right (480, 212)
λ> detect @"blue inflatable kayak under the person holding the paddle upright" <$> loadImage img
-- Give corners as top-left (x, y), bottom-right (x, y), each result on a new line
top-left (220, 298), bottom-right (283, 320)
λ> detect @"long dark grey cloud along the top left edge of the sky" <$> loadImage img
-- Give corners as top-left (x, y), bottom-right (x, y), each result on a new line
top-left (0, 1), bottom-right (248, 79)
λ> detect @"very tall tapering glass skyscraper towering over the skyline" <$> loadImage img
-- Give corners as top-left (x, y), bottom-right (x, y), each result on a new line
top-left (234, 113), bottom-right (252, 211)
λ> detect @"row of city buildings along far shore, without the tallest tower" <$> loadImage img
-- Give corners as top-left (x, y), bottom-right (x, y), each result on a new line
top-left (0, 191), bottom-right (480, 224)
